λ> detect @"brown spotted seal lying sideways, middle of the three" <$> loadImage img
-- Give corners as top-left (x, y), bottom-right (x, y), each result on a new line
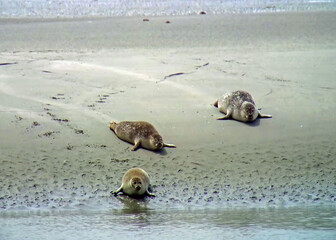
top-left (110, 121), bottom-right (176, 151)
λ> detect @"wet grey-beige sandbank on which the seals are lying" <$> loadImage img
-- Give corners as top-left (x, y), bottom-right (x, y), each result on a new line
top-left (0, 12), bottom-right (336, 211)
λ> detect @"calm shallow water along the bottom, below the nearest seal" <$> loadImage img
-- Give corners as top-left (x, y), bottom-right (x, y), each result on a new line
top-left (0, 202), bottom-right (336, 240)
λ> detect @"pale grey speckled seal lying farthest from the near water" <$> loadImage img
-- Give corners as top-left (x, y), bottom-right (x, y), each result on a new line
top-left (214, 90), bottom-right (272, 122)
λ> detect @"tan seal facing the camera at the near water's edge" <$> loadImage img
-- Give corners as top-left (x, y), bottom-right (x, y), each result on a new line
top-left (111, 168), bottom-right (155, 197)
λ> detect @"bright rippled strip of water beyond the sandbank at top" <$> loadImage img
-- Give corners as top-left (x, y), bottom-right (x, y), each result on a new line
top-left (0, 0), bottom-right (336, 17)
